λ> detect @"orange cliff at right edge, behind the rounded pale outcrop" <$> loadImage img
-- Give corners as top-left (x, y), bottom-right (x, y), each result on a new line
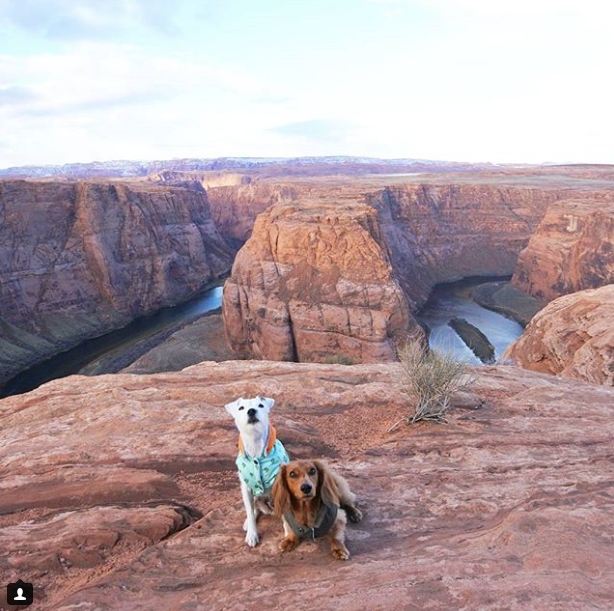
top-left (512, 194), bottom-right (614, 301)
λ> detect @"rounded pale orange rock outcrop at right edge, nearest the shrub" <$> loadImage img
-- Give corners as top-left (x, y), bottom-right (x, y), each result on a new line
top-left (503, 284), bottom-right (614, 386)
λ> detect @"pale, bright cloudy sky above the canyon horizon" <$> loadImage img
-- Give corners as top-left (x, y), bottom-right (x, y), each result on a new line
top-left (0, 0), bottom-right (614, 168)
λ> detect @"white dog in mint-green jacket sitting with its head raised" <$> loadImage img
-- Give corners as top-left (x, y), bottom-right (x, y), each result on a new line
top-left (225, 397), bottom-right (290, 547)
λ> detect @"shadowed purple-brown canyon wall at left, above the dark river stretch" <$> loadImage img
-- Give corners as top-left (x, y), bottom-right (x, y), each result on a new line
top-left (0, 180), bottom-right (233, 382)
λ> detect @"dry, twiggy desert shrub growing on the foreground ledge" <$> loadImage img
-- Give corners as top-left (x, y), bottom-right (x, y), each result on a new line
top-left (389, 341), bottom-right (474, 431)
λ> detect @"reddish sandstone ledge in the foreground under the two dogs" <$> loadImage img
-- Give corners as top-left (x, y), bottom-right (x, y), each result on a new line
top-left (0, 361), bottom-right (614, 611)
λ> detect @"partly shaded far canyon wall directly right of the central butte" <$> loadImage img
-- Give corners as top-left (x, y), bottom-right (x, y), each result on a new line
top-left (367, 183), bottom-right (572, 308)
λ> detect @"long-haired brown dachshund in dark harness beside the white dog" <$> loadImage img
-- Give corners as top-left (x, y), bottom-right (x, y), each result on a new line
top-left (272, 460), bottom-right (362, 560)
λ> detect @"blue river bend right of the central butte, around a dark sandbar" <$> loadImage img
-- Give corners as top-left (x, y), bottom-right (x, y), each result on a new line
top-left (416, 278), bottom-right (523, 364)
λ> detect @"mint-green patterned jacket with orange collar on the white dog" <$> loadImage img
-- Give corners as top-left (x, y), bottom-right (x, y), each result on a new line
top-left (235, 425), bottom-right (290, 496)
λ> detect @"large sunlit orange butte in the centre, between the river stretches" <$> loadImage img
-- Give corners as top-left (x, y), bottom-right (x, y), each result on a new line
top-left (222, 200), bottom-right (422, 362)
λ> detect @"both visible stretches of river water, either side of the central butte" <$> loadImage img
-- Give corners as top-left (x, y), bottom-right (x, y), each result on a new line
top-left (0, 278), bottom-right (522, 398)
